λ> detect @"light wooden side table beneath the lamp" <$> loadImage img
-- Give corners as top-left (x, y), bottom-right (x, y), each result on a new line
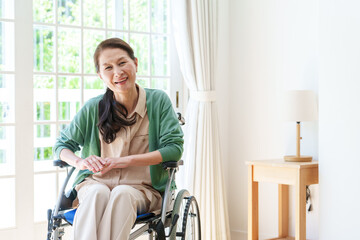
top-left (246, 159), bottom-right (319, 240)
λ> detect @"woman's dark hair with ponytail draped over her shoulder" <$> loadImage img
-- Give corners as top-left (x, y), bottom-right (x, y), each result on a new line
top-left (94, 38), bottom-right (136, 144)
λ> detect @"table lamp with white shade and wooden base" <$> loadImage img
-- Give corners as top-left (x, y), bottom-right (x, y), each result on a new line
top-left (284, 90), bottom-right (317, 162)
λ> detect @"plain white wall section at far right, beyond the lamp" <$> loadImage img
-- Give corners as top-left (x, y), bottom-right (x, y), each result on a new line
top-left (319, 0), bottom-right (360, 240)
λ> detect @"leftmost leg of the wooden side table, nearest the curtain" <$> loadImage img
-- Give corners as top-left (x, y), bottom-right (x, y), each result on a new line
top-left (248, 165), bottom-right (259, 240)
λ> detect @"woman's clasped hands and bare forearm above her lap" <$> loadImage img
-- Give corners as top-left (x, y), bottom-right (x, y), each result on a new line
top-left (76, 155), bottom-right (130, 174)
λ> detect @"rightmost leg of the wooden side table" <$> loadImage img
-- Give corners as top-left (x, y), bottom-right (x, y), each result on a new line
top-left (295, 169), bottom-right (306, 240)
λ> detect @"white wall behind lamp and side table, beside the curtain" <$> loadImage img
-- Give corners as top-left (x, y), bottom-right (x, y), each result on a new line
top-left (224, 0), bottom-right (319, 239)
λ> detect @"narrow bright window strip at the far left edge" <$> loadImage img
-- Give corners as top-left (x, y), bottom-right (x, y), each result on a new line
top-left (0, 0), bottom-right (15, 231)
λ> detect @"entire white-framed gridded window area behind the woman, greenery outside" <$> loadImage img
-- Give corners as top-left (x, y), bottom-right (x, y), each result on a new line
top-left (0, 0), bottom-right (182, 239)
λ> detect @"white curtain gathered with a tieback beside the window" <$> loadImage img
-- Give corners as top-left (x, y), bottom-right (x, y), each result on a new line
top-left (171, 0), bottom-right (230, 240)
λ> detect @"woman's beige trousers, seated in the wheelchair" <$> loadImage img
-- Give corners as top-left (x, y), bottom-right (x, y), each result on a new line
top-left (73, 180), bottom-right (161, 240)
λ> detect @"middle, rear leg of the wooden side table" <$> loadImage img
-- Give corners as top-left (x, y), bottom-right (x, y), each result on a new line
top-left (279, 184), bottom-right (289, 238)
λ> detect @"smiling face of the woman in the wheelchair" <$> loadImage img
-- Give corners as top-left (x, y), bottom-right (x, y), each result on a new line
top-left (98, 48), bottom-right (137, 97)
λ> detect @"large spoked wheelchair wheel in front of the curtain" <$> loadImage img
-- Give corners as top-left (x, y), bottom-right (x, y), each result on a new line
top-left (170, 190), bottom-right (201, 240)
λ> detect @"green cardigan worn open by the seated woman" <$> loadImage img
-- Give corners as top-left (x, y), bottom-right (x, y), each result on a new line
top-left (54, 89), bottom-right (184, 192)
